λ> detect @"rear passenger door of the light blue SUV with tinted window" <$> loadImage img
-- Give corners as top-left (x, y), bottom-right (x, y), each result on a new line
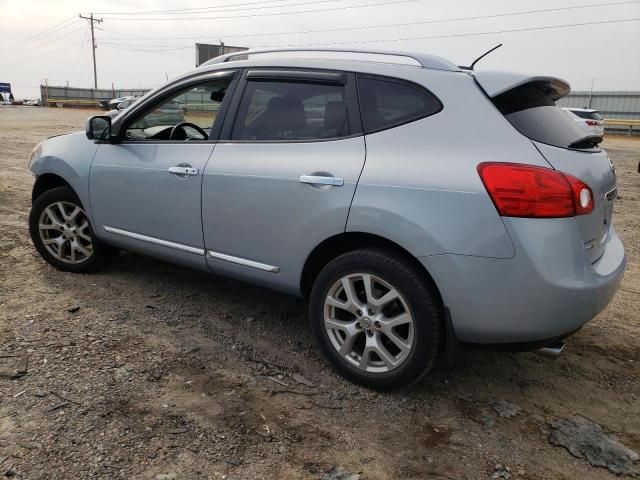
top-left (202, 69), bottom-right (365, 293)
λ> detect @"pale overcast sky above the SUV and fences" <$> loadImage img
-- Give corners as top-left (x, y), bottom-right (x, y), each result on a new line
top-left (0, 0), bottom-right (640, 99)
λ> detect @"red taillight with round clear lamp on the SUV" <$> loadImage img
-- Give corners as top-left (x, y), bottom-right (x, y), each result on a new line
top-left (478, 163), bottom-right (593, 218)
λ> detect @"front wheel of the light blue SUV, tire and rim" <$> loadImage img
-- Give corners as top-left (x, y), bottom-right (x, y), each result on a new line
top-left (29, 186), bottom-right (110, 273)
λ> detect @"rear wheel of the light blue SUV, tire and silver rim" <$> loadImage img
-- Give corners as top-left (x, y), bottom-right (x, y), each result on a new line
top-left (309, 248), bottom-right (444, 390)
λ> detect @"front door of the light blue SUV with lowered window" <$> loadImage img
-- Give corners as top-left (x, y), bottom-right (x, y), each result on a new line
top-left (89, 71), bottom-right (234, 269)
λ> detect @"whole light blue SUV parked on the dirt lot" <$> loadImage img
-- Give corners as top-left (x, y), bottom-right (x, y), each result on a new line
top-left (30, 50), bottom-right (626, 389)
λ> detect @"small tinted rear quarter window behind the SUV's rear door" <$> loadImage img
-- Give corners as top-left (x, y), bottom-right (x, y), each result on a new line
top-left (358, 75), bottom-right (442, 133)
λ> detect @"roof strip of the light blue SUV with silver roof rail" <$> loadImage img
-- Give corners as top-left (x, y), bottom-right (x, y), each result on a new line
top-left (199, 47), bottom-right (461, 72)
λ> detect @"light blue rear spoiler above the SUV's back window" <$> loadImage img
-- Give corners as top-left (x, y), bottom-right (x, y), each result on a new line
top-left (472, 70), bottom-right (571, 102)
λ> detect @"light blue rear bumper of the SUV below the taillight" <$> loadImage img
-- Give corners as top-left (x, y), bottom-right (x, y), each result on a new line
top-left (419, 218), bottom-right (626, 344)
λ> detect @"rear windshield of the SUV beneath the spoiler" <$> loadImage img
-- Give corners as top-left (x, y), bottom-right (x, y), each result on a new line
top-left (493, 82), bottom-right (595, 148)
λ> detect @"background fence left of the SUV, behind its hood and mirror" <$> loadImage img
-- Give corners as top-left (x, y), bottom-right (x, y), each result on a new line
top-left (40, 85), bottom-right (149, 108)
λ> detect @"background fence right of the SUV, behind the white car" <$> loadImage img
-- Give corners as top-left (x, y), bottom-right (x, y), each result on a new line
top-left (558, 92), bottom-right (640, 133)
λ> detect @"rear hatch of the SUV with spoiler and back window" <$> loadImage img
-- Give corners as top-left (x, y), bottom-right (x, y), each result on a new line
top-left (474, 71), bottom-right (617, 262)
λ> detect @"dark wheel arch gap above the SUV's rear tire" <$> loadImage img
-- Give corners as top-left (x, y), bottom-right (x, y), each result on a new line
top-left (300, 232), bottom-right (443, 305)
